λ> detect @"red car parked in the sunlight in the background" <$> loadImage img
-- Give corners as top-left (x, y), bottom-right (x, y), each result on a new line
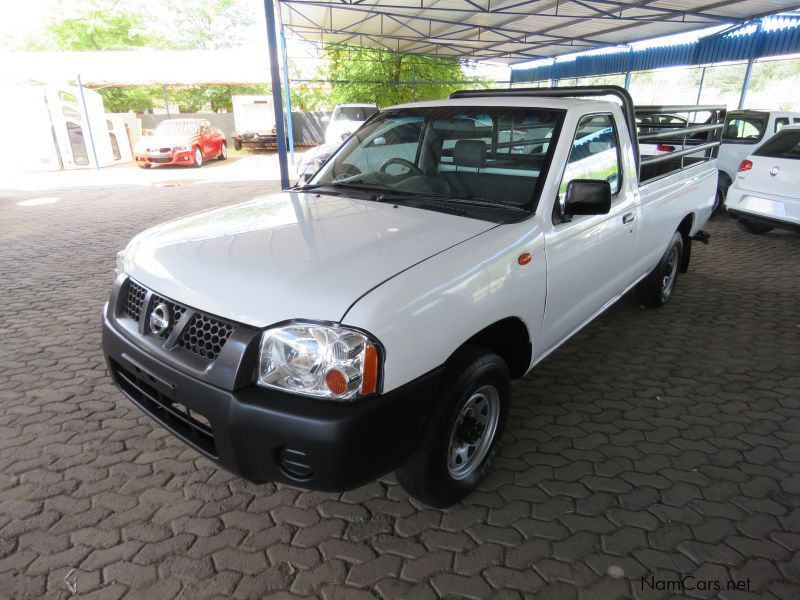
top-left (133, 119), bottom-right (228, 169)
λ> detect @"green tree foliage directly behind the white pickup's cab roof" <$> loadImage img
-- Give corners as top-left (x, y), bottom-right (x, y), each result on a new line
top-left (321, 45), bottom-right (483, 108)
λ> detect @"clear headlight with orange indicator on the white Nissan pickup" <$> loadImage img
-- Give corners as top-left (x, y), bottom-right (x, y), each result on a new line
top-left (258, 323), bottom-right (380, 400)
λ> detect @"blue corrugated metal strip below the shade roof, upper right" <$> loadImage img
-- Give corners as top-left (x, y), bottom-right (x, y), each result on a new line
top-left (511, 16), bottom-right (800, 83)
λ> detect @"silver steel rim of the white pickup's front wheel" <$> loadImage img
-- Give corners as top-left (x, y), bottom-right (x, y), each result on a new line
top-left (447, 385), bottom-right (500, 480)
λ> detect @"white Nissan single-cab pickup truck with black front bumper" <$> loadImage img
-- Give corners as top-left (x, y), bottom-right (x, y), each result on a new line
top-left (103, 86), bottom-right (724, 507)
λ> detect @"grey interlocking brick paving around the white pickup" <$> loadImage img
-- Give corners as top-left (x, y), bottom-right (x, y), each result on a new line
top-left (0, 182), bottom-right (800, 600)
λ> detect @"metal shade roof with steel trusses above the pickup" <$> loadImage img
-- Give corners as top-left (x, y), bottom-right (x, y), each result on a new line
top-left (278, 0), bottom-right (798, 64)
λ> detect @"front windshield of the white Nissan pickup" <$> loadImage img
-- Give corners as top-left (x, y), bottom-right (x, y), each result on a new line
top-left (311, 106), bottom-right (563, 210)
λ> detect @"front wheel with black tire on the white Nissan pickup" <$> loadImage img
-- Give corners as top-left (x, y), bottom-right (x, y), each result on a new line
top-left (397, 347), bottom-right (510, 508)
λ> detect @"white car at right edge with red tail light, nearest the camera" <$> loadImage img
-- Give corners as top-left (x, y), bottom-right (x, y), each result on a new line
top-left (725, 125), bottom-right (800, 234)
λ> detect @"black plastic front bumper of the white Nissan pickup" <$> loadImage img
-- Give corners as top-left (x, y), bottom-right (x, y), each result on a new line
top-left (103, 316), bottom-right (441, 491)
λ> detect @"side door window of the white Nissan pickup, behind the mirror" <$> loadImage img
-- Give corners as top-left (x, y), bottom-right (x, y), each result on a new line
top-left (559, 114), bottom-right (622, 199)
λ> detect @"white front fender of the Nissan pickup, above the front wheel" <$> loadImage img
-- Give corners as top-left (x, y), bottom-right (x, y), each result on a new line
top-left (342, 217), bottom-right (547, 391)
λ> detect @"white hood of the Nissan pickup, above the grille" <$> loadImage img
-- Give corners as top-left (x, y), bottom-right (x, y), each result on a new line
top-left (124, 192), bottom-right (495, 327)
